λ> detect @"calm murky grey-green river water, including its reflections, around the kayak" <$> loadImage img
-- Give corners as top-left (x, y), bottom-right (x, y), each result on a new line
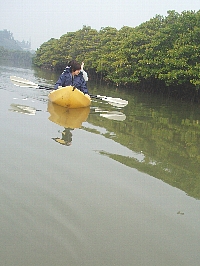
top-left (0, 66), bottom-right (200, 266)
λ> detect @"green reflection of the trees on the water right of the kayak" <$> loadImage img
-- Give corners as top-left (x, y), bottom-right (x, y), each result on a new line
top-left (42, 71), bottom-right (200, 199)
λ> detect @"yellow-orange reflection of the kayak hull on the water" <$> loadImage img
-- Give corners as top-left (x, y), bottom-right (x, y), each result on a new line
top-left (47, 102), bottom-right (90, 128)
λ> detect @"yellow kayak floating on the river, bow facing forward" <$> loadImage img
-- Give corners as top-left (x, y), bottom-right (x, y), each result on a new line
top-left (49, 86), bottom-right (91, 108)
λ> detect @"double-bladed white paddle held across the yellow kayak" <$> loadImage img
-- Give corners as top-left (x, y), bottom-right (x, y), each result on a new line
top-left (10, 76), bottom-right (128, 107)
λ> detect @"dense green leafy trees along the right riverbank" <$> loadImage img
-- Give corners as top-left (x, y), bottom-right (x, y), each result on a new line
top-left (34, 11), bottom-right (200, 89)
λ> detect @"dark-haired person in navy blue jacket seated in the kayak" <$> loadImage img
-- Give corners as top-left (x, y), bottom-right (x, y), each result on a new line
top-left (54, 60), bottom-right (89, 94)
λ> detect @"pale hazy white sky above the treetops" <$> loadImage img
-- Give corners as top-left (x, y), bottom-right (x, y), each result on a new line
top-left (0, 0), bottom-right (200, 49)
